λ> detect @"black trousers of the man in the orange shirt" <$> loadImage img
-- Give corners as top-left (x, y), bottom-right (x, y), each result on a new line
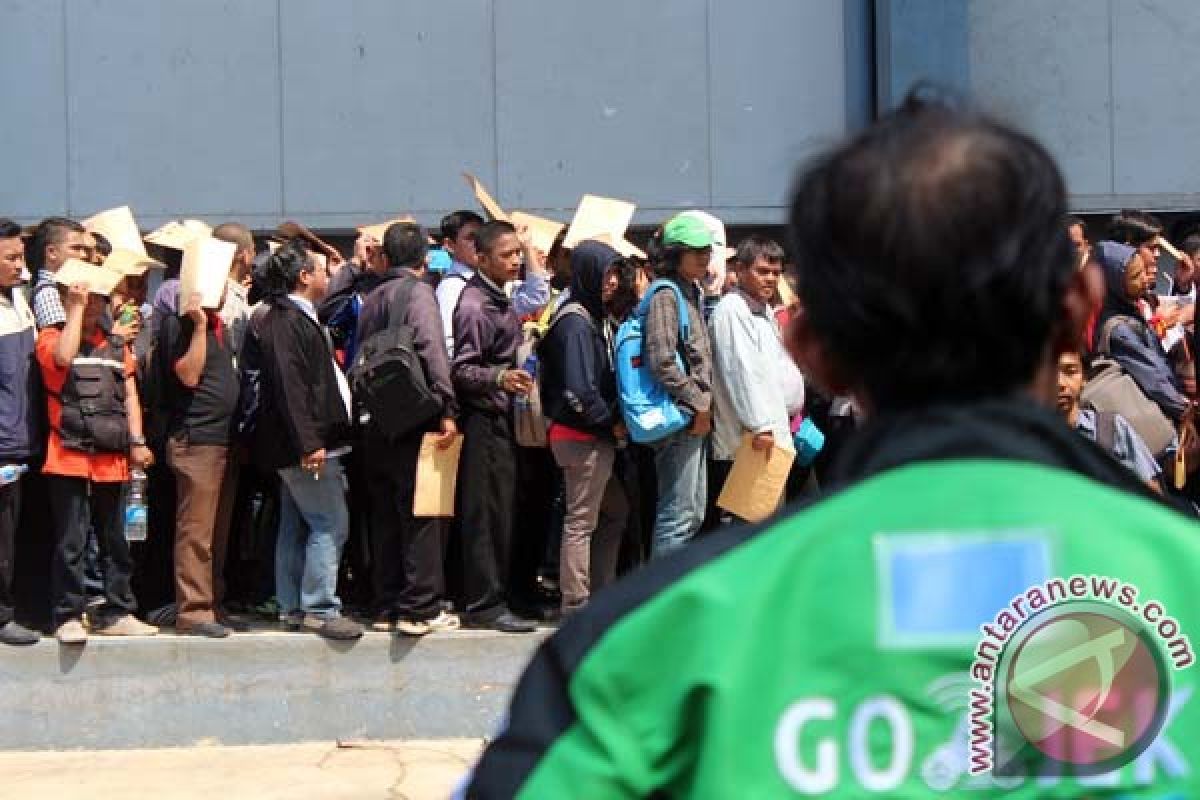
top-left (46, 475), bottom-right (137, 625)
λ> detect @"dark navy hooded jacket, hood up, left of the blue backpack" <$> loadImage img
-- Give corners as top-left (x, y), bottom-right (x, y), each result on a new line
top-left (538, 241), bottom-right (620, 438)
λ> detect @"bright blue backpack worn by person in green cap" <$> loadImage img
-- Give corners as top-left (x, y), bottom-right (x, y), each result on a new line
top-left (614, 279), bottom-right (691, 444)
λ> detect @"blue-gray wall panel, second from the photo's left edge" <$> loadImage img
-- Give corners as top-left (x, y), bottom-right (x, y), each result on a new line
top-left (67, 0), bottom-right (280, 225)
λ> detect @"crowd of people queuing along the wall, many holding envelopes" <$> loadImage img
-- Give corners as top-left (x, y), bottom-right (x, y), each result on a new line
top-left (0, 170), bottom-right (1200, 644)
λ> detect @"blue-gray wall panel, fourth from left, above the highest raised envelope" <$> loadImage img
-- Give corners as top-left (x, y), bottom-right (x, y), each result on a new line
top-left (496, 0), bottom-right (709, 219)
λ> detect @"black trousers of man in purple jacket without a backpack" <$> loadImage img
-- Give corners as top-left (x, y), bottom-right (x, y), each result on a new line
top-left (458, 411), bottom-right (517, 621)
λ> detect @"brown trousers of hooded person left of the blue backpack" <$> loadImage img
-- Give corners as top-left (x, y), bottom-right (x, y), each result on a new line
top-left (550, 441), bottom-right (629, 612)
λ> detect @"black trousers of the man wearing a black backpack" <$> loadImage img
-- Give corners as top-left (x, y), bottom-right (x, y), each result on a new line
top-left (365, 433), bottom-right (446, 620)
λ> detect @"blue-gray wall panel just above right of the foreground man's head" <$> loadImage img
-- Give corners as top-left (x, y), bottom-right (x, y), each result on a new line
top-left (967, 0), bottom-right (1112, 194)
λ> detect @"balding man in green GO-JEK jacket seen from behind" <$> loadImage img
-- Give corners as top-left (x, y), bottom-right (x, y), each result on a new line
top-left (463, 92), bottom-right (1200, 800)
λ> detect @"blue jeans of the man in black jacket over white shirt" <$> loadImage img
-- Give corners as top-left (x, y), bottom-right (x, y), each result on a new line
top-left (275, 458), bottom-right (350, 616)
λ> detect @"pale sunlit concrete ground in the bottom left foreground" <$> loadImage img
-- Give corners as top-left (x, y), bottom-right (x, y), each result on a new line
top-left (0, 739), bottom-right (482, 800)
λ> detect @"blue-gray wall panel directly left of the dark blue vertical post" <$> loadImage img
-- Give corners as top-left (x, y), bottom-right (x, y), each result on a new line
top-left (709, 0), bottom-right (847, 209)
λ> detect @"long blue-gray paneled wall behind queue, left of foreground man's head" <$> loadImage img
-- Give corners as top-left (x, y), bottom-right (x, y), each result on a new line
top-left (0, 0), bottom-right (870, 229)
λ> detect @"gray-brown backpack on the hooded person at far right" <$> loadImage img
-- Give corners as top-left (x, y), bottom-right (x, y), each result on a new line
top-left (1080, 315), bottom-right (1176, 458)
